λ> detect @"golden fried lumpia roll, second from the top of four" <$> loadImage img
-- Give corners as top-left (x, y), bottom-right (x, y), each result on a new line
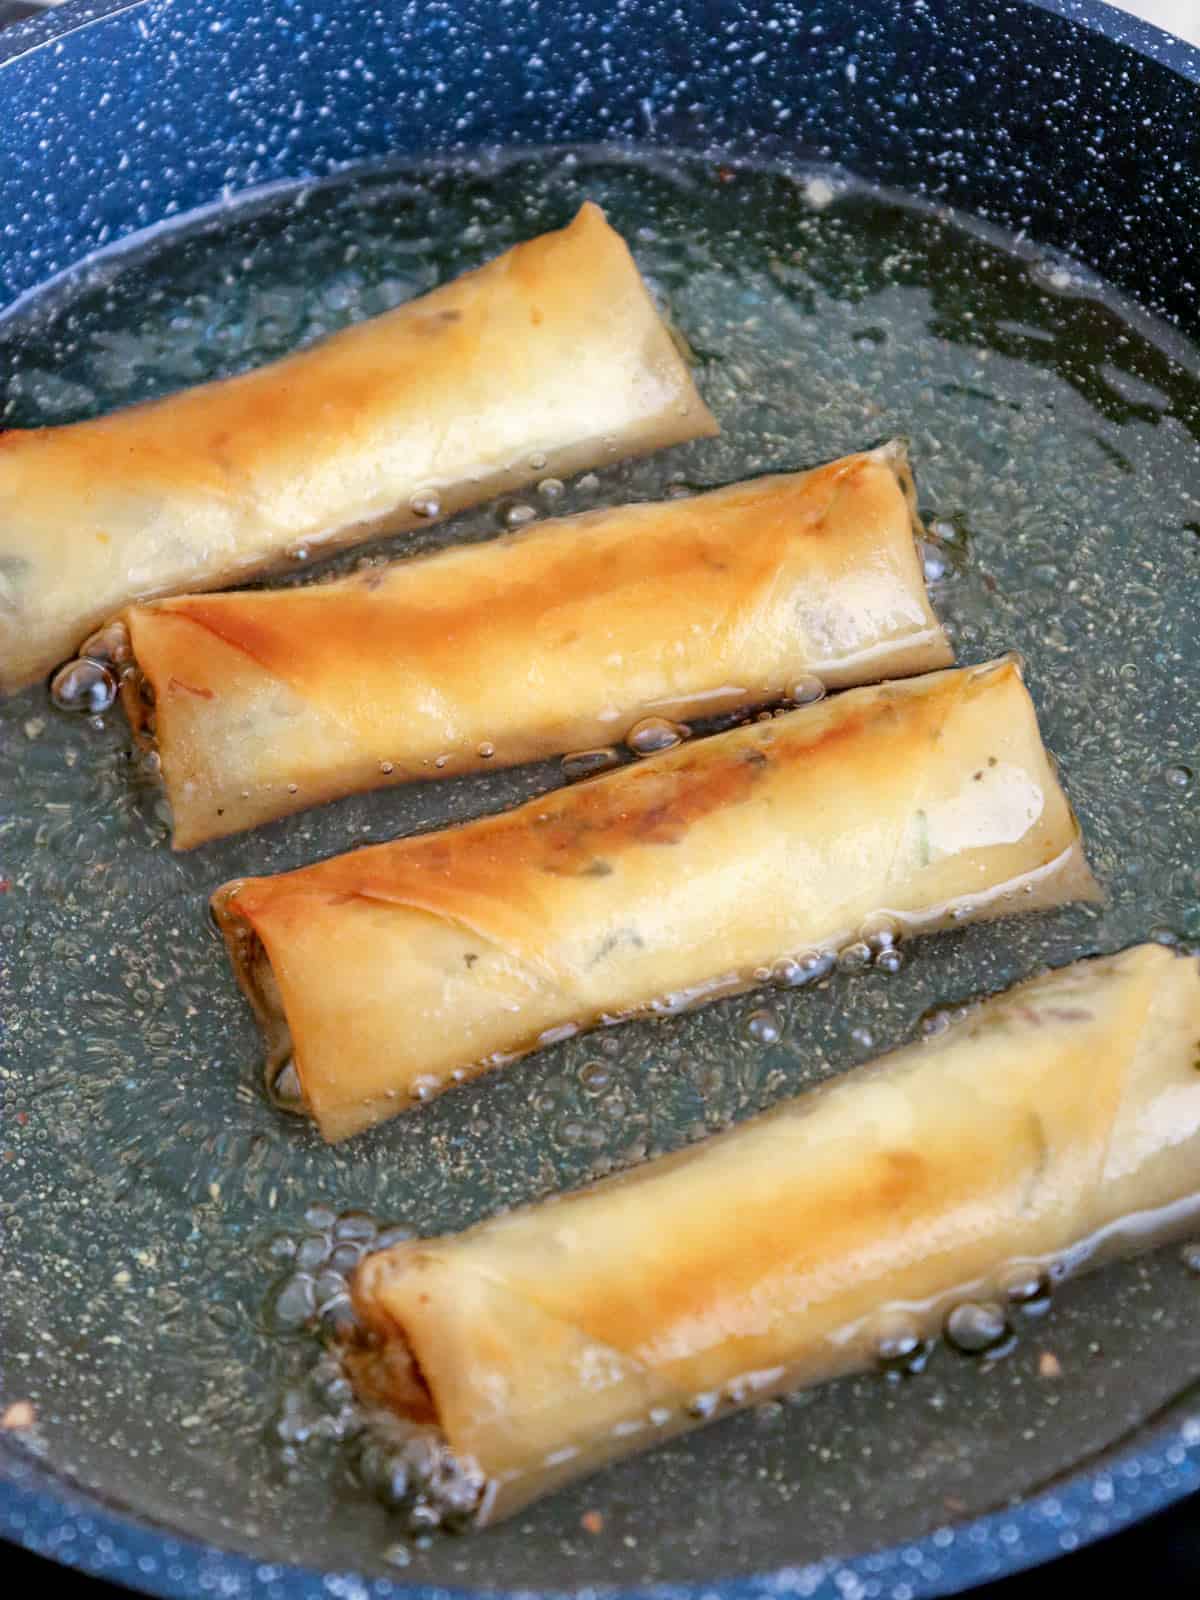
top-left (117, 445), bottom-right (952, 850)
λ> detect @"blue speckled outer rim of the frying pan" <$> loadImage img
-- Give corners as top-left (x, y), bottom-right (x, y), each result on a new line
top-left (0, 0), bottom-right (1200, 1600)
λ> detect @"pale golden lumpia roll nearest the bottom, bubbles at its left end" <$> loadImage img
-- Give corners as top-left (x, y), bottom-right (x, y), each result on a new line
top-left (349, 946), bottom-right (1200, 1522)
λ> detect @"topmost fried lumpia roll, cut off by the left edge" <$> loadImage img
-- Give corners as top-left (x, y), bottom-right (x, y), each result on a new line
top-left (0, 203), bottom-right (717, 691)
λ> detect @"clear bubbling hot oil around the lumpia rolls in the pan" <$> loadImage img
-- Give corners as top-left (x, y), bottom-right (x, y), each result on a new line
top-left (0, 152), bottom-right (1200, 1587)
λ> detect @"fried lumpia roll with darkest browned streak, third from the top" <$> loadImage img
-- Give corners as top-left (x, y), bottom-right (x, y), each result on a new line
top-left (213, 659), bottom-right (1094, 1139)
